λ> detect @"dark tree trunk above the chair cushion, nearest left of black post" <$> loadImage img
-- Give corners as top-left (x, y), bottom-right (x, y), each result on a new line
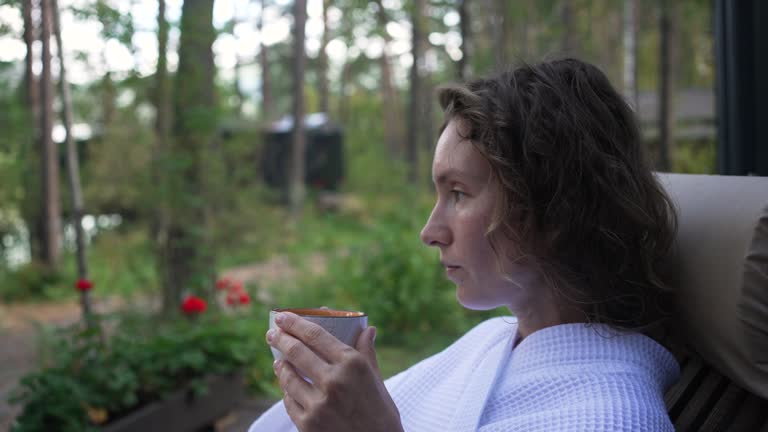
top-left (657, 0), bottom-right (677, 171)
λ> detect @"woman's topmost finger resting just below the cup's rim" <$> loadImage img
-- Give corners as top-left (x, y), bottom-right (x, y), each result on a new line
top-left (275, 312), bottom-right (350, 362)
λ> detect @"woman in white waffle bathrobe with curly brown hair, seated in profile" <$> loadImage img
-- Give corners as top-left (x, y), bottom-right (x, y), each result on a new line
top-left (251, 59), bottom-right (679, 432)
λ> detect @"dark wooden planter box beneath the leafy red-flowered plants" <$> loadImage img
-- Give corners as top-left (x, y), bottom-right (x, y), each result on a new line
top-left (102, 373), bottom-right (245, 432)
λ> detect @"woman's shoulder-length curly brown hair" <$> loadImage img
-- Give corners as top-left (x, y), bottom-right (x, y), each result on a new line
top-left (438, 58), bottom-right (677, 333)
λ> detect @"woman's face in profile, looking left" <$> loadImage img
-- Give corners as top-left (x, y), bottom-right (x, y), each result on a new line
top-left (421, 119), bottom-right (540, 312)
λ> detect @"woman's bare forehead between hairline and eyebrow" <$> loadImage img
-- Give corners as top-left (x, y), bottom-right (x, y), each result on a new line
top-left (432, 119), bottom-right (490, 183)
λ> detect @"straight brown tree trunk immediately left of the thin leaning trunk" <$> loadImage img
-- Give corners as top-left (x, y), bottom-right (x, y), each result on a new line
top-left (40, 0), bottom-right (61, 269)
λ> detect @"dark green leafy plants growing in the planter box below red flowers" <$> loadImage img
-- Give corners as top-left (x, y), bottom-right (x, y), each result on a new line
top-left (11, 311), bottom-right (273, 432)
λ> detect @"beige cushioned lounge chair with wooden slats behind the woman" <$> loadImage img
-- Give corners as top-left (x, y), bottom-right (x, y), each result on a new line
top-left (659, 174), bottom-right (768, 432)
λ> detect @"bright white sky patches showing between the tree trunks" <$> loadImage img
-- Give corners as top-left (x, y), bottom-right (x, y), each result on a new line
top-left (0, 0), bottom-right (461, 94)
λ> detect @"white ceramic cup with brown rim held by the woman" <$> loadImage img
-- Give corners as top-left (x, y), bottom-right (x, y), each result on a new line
top-left (269, 308), bottom-right (368, 360)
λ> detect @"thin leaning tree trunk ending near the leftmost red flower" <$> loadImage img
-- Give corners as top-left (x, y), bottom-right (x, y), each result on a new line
top-left (50, 0), bottom-right (94, 327)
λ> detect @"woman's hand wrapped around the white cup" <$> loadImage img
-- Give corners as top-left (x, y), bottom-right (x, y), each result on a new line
top-left (267, 312), bottom-right (402, 432)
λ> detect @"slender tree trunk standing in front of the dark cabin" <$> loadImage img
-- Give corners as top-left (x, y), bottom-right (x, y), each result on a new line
top-left (289, 0), bottom-right (307, 216)
